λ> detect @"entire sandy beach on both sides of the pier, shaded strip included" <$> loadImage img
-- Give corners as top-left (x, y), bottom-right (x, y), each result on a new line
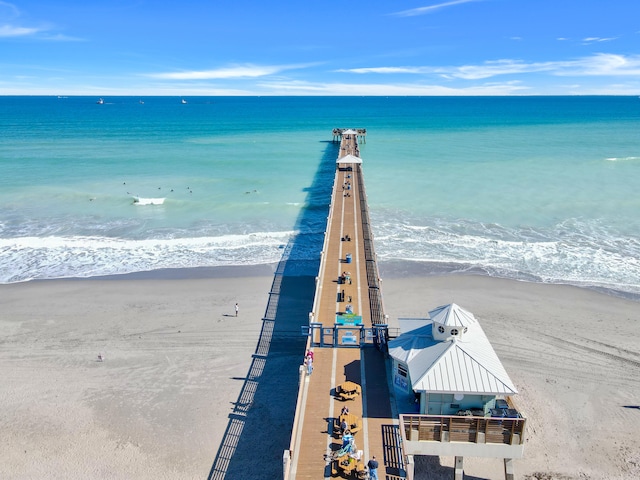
top-left (0, 267), bottom-right (640, 480)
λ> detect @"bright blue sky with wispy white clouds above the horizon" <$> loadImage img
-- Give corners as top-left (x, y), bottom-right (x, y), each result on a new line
top-left (0, 0), bottom-right (640, 96)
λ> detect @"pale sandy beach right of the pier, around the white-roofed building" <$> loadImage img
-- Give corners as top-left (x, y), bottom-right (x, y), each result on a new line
top-left (382, 268), bottom-right (640, 480)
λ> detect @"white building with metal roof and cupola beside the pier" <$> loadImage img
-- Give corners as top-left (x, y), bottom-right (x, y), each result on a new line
top-left (389, 303), bottom-right (525, 479)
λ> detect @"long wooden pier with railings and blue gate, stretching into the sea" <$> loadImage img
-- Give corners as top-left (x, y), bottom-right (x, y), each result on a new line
top-left (283, 129), bottom-right (405, 480)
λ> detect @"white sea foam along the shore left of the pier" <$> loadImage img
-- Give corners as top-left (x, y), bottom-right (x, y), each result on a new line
top-left (0, 232), bottom-right (296, 283)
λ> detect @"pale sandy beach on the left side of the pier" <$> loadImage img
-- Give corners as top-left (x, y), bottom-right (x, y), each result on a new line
top-left (0, 269), bottom-right (308, 479)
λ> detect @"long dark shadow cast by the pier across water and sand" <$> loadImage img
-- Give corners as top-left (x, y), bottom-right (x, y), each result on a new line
top-left (207, 142), bottom-right (339, 480)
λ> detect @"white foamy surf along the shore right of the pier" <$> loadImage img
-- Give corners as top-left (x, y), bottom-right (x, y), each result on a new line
top-left (373, 220), bottom-right (640, 294)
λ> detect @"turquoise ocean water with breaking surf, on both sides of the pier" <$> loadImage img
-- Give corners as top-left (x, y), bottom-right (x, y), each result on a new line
top-left (0, 97), bottom-right (640, 296)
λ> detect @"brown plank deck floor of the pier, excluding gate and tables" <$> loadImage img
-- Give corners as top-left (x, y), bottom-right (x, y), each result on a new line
top-left (285, 135), bottom-right (403, 480)
